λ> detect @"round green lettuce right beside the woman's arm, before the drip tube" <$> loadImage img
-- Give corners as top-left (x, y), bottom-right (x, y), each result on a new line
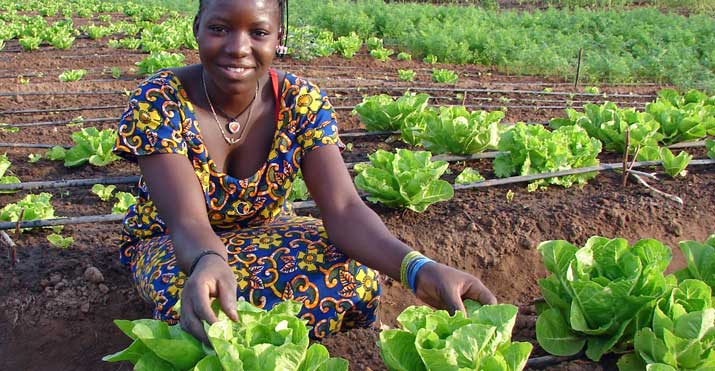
top-left (355, 149), bottom-right (454, 212)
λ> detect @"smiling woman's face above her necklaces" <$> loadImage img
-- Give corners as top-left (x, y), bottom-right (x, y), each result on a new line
top-left (194, 0), bottom-right (280, 94)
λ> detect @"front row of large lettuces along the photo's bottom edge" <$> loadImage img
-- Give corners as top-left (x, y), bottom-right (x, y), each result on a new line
top-left (104, 235), bottom-right (715, 371)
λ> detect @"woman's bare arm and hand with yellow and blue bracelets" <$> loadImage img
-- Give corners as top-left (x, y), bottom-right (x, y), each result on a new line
top-left (302, 145), bottom-right (496, 310)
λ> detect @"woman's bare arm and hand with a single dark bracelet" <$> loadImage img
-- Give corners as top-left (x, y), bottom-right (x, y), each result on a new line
top-left (138, 154), bottom-right (237, 341)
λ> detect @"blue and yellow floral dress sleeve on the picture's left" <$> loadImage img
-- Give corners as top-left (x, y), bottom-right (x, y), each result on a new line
top-left (114, 79), bottom-right (187, 162)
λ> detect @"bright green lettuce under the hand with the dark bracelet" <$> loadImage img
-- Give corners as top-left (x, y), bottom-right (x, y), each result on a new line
top-left (102, 300), bottom-right (348, 371)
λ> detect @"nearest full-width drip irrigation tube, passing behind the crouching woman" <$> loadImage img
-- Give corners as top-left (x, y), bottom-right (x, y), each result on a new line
top-left (0, 160), bottom-right (715, 230)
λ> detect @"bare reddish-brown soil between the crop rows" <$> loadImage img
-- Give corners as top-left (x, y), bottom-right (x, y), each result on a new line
top-left (0, 24), bottom-right (715, 370)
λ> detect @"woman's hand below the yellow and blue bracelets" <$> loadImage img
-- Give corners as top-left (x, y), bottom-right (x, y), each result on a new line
top-left (415, 262), bottom-right (497, 313)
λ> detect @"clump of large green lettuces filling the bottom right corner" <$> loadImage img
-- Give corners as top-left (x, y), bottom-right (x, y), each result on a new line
top-left (536, 235), bottom-right (715, 371)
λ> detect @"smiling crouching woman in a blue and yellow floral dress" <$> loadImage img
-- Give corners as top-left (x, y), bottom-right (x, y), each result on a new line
top-left (115, 0), bottom-right (496, 341)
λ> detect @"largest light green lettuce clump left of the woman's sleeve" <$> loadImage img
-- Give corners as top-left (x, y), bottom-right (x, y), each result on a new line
top-left (47, 127), bottom-right (119, 167)
